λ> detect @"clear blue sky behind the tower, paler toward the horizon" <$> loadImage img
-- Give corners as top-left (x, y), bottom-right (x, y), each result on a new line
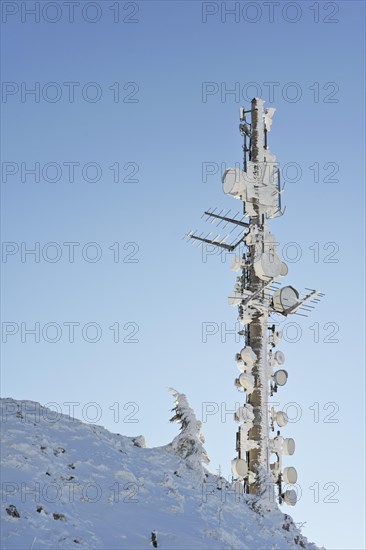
top-left (1, 0), bottom-right (365, 549)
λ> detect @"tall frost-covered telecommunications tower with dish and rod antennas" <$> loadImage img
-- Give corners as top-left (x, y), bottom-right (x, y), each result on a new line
top-left (187, 98), bottom-right (323, 505)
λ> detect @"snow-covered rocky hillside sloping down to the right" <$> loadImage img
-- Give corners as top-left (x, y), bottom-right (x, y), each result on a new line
top-left (1, 399), bottom-right (316, 550)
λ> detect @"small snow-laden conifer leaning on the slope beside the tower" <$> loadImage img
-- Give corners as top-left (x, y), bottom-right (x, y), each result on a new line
top-left (170, 388), bottom-right (210, 469)
